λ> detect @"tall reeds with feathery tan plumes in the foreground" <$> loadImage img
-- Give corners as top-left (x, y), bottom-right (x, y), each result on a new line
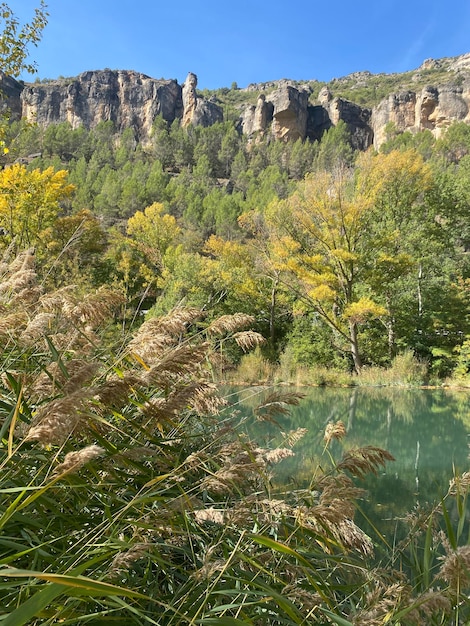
top-left (0, 255), bottom-right (470, 626)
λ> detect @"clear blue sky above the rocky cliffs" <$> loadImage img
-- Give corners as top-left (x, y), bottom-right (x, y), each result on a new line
top-left (12, 0), bottom-right (470, 89)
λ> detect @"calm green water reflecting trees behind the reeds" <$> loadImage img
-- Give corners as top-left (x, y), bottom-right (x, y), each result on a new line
top-left (223, 388), bottom-right (470, 532)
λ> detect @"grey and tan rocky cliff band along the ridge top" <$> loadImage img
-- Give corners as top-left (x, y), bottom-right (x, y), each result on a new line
top-left (0, 53), bottom-right (470, 150)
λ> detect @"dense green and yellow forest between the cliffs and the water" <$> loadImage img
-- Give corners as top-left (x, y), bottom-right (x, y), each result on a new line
top-left (0, 108), bottom-right (470, 379)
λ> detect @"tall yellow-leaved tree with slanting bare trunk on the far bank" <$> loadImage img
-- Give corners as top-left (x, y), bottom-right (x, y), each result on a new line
top-left (267, 163), bottom-right (385, 372)
